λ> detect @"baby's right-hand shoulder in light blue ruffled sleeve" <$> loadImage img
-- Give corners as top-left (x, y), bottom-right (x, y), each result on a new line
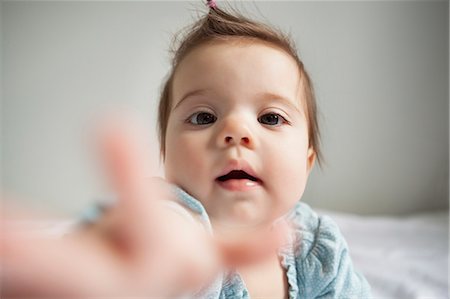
top-left (286, 202), bottom-right (370, 298)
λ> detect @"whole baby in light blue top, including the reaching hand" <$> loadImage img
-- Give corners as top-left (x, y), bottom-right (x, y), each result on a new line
top-left (3, 1), bottom-right (370, 299)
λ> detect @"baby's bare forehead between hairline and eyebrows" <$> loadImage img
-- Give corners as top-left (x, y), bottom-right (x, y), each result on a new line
top-left (172, 38), bottom-right (304, 106)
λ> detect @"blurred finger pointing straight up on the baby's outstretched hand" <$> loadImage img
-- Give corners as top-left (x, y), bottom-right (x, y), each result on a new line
top-left (94, 115), bottom-right (171, 251)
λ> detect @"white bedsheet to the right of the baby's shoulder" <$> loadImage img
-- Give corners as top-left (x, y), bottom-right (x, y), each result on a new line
top-left (319, 210), bottom-right (449, 299)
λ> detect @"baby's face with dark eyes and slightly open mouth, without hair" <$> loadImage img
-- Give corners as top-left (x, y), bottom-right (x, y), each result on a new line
top-left (165, 42), bottom-right (315, 230)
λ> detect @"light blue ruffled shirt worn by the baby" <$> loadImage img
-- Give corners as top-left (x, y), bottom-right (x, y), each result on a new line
top-left (174, 187), bottom-right (371, 299)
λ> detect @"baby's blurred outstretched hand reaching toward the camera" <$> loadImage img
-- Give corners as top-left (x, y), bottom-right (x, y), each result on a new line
top-left (0, 116), bottom-right (220, 298)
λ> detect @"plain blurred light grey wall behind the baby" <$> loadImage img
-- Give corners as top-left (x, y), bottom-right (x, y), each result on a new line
top-left (0, 0), bottom-right (449, 215)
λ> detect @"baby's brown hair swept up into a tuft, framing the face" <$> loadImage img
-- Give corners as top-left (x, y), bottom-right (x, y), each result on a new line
top-left (158, 0), bottom-right (323, 165)
